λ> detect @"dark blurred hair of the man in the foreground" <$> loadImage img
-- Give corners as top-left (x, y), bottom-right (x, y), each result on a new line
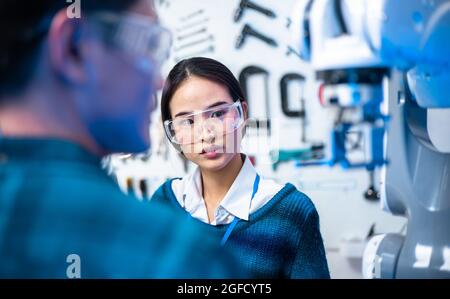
top-left (0, 0), bottom-right (138, 96)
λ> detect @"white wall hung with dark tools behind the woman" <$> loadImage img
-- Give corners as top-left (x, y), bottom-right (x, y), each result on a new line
top-left (113, 0), bottom-right (405, 278)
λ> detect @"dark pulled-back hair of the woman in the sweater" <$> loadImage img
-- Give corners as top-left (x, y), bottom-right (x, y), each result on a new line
top-left (161, 57), bottom-right (246, 122)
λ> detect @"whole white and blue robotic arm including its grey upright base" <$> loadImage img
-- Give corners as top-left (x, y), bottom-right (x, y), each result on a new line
top-left (293, 0), bottom-right (450, 278)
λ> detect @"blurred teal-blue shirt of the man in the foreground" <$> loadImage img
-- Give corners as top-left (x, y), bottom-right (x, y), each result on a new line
top-left (0, 138), bottom-right (237, 278)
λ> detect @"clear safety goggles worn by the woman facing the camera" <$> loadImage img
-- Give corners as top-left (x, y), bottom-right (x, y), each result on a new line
top-left (164, 101), bottom-right (244, 145)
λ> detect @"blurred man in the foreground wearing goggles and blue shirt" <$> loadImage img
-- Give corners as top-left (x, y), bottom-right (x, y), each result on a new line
top-left (0, 0), bottom-right (239, 278)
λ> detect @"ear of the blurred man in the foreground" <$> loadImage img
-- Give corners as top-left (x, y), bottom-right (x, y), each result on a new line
top-left (48, 10), bottom-right (86, 85)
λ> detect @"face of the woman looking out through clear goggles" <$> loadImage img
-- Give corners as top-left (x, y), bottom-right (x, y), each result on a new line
top-left (169, 76), bottom-right (247, 171)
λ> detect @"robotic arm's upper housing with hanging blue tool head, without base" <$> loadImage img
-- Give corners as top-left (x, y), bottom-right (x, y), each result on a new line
top-left (293, 0), bottom-right (450, 169)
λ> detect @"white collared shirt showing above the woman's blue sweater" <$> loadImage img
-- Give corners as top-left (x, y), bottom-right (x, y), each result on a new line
top-left (172, 157), bottom-right (284, 225)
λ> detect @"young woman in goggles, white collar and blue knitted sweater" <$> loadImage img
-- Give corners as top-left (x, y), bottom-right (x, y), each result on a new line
top-left (152, 58), bottom-right (329, 278)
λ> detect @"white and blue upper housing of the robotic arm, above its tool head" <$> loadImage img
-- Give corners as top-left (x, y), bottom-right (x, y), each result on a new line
top-left (295, 0), bottom-right (450, 108)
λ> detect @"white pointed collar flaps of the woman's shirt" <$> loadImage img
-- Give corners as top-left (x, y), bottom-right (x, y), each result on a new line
top-left (185, 157), bottom-right (257, 221)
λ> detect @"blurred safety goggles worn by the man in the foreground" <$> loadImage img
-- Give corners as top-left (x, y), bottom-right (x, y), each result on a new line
top-left (89, 12), bottom-right (172, 72)
